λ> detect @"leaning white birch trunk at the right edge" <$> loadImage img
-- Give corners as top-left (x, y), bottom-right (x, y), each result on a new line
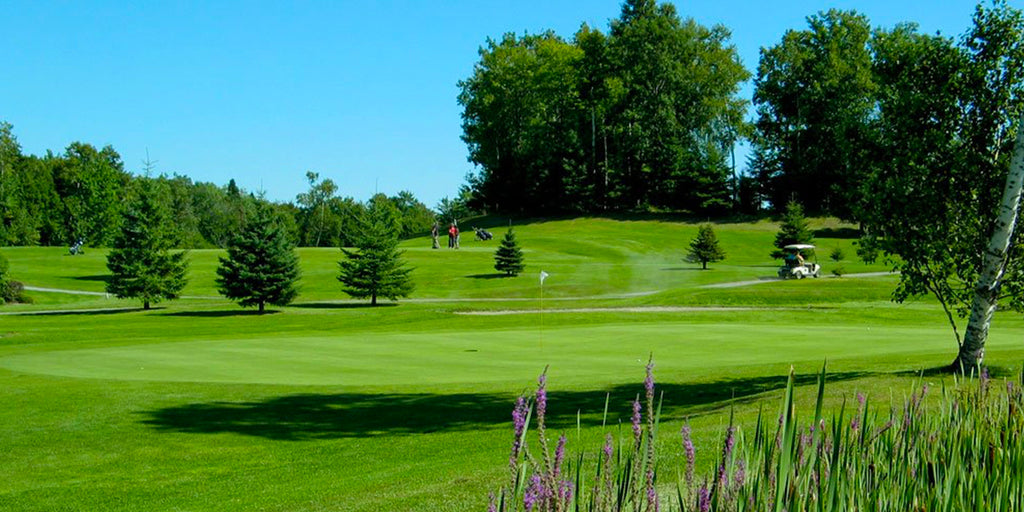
top-left (952, 116), bottom-right (1024, 373)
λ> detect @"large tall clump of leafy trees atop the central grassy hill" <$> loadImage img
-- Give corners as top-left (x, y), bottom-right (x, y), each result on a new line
top-left (459, 2), bottom-right (749, 212)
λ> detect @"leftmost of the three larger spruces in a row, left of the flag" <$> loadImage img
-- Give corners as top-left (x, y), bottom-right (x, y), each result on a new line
top-left (106, 185), bottom-right (188, 309)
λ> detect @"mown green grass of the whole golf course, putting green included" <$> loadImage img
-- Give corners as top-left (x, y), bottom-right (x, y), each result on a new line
top-left (0, 219), bottom-right (1011, 511)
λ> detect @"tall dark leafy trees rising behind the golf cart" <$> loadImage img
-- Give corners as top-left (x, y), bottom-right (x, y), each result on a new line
top-left (754, 9), bottom-right (877, 218)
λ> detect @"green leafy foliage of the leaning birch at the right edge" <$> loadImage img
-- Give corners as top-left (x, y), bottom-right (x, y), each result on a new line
top-left (861, 2), bottom-right (1024, 354)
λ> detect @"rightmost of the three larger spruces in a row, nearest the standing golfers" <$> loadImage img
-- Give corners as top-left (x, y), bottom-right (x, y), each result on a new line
top-left (338, 201), bottom-right (414, 306)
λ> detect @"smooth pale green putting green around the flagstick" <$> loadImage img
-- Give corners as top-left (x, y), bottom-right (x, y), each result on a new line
top-left (0, 314), bottom-right (991, 387)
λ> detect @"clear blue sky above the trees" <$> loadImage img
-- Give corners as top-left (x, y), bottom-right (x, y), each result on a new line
top-left (0, 0), bottom-right (983, 207)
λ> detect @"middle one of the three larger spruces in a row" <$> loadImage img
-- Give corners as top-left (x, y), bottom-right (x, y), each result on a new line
top-left (217, 202), bottom-right (299, 313)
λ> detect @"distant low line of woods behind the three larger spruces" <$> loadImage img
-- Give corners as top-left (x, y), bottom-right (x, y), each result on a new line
top-left (0, 122), bottom-right (444, 248)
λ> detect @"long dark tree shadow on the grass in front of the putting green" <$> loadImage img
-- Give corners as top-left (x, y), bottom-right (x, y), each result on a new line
top-left (140, 373), bottom-right (868, 440)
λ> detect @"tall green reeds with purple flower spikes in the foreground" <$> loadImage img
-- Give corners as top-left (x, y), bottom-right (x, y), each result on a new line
top-left (488, 362), bottom-right (1024, 512)
